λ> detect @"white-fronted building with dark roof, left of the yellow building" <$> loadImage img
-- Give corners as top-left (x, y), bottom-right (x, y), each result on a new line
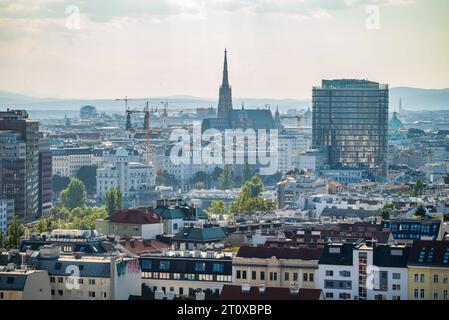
top-left (318, 242), bottom-right (410, 300)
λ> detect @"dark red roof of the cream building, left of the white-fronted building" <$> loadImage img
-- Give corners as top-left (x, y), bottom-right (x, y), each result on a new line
top-left (237, 246), bottom-right (322, 260)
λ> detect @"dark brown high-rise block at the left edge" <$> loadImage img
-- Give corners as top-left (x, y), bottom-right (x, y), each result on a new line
top-left (0, 109), bottom-right (39, 219)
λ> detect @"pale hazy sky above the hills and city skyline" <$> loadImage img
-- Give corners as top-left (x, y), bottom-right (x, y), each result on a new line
top-left (0, 0), bottom-right (449, 99)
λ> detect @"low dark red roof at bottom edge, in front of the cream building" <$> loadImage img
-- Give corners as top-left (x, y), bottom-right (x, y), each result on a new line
top-left (220, 284), bottom-right (322, 300)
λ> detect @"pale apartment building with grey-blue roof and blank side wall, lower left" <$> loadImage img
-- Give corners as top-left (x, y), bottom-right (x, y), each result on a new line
top-left (29, 246), bottom-right (142, 300)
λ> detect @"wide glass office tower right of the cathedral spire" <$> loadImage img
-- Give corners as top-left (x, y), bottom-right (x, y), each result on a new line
top-left (312, 79), bottom-right (388, 178)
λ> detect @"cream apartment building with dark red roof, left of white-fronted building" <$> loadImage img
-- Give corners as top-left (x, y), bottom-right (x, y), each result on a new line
top-left (232, 246), bottom-right (321, 288)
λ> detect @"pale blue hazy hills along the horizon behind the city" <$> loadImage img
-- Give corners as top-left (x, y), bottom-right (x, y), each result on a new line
top-left (0, 87), bottom-right (449, 112)
